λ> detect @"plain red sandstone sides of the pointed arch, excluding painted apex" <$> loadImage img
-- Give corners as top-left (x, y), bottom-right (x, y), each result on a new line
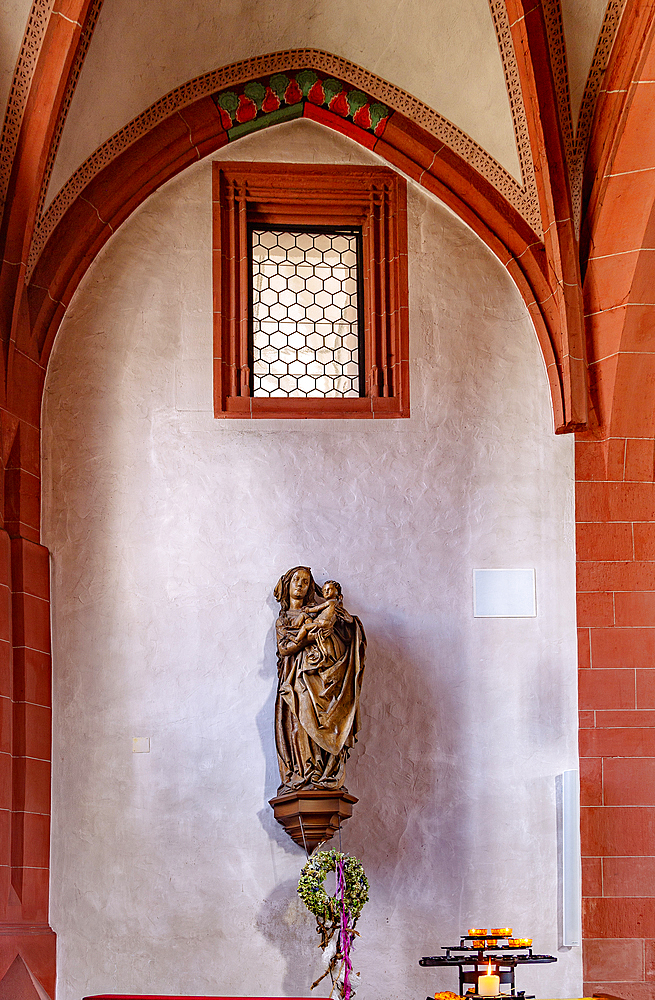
top-left (25, 62), bottom-right (579, 431)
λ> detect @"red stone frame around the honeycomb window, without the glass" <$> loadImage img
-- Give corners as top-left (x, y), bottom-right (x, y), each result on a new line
top-left (212, 163), bottom-right (409, 418)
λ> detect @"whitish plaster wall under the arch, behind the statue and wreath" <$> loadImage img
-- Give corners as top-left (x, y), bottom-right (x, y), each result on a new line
top-left (43, 121), bottom-right (582, 1000)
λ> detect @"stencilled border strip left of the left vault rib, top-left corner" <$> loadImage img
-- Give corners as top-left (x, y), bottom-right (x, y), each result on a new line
top-left (0, 0), bottom-right (54, 223)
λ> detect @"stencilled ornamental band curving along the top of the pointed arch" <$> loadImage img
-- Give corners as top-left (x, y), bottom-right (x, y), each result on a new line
top-left (28, 46), bottom-right (540, 276)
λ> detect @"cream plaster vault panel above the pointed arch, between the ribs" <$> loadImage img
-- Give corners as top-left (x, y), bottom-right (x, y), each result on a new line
top-left (48, 0), bottom-right (521, 207)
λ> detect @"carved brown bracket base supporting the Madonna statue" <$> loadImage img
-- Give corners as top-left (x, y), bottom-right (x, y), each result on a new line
top-left (269, 788), bottom-right (359, 853)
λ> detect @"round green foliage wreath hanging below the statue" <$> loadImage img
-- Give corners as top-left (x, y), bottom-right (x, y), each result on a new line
top-left (298, 851), bottom-right (368, 927)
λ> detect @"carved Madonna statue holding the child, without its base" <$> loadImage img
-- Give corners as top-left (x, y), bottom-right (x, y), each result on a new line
top-left (275, 566), bottom-right (366, 801)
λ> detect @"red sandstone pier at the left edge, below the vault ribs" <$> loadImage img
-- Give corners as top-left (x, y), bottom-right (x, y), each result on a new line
top-left (0, 421), bottom-right (56, 1000)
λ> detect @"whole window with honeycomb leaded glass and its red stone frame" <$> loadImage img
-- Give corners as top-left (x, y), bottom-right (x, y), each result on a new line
top-left (212, 162), bottom-right (410, 420)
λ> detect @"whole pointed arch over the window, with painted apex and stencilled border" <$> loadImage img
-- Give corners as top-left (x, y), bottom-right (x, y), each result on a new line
top-left (28, 50), bottom-right (581, 432)
